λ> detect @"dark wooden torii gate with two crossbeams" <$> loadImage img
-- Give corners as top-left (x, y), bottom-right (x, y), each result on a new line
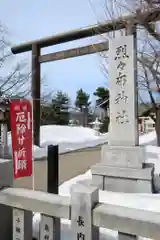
top-left (11, 8), bottom-right (160, 146)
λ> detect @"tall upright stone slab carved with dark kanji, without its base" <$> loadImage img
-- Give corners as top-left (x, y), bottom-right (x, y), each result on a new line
top-left (109, 35), bottom-right (137, 146)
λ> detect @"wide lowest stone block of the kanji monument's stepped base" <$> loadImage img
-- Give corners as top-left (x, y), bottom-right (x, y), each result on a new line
top-left (91, 163), bottom-right (154, 193)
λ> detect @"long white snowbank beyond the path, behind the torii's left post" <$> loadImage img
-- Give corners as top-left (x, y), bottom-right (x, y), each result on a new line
top-left (8, 125), bottom-right (108, 158)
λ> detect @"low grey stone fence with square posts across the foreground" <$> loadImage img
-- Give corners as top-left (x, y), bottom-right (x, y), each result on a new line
top-left (0, 183), bottom-right (160, 240)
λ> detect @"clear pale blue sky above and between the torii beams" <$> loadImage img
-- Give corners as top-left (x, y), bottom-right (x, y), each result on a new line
top-left (0, 0), bottom-right (107, 104)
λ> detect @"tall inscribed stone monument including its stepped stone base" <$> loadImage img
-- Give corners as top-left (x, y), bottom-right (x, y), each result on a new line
top-left (91, 34), bottom-right (154, 193)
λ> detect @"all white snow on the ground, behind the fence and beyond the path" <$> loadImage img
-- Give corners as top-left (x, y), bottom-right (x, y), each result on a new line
top-left (33, 126), bottom-right (160, 240)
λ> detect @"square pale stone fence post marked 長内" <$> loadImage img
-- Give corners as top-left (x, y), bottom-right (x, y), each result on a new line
top-left (71, 184), bottom-right (99, 240)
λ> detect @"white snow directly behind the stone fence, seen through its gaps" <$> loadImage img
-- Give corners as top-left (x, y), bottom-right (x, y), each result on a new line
top-left (33, 171), bottom-right (160, 240)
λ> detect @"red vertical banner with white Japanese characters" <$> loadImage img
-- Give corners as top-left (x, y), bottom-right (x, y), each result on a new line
top-left (10, 100), bottom-right (32, 179)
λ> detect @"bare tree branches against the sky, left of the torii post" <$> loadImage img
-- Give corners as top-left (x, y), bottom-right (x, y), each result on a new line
top-left (0, 22), bottom-right (51, 102)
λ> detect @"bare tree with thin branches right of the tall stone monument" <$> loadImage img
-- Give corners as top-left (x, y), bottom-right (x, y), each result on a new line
top-left (92, 0), bottom-right (160, 146)
